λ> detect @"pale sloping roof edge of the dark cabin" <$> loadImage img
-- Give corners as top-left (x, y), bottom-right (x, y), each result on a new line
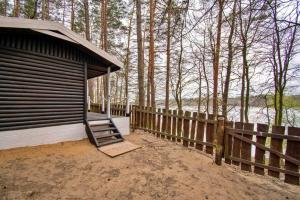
top-left (0, 17), bottom-right (123, 71)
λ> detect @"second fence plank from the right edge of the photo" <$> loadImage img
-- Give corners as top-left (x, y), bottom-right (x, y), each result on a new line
top-left (268, 126), bottom-right (285, 178)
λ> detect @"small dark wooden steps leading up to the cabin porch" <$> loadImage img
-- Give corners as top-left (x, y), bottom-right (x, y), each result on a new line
top-left (85, 119), bottom-right (124, 147)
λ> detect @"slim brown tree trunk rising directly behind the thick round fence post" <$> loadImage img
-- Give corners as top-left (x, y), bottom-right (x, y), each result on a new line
top-left (222, 0), bottom-right (237, 119)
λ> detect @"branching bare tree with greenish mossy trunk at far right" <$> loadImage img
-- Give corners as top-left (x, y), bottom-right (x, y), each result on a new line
top-left (268, 0), bottom-right (300, 126)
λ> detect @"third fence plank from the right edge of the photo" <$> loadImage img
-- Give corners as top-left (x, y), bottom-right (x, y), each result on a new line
top-left (254, 124), bottom-right (269, 175)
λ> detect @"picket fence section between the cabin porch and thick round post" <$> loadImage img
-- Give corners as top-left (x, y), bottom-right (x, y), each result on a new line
top-left (131, 106), bottom-right (220, 158)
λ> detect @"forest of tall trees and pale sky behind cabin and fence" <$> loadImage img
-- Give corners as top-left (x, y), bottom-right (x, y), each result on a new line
top-left (0, 0), bottom-right (300, 126)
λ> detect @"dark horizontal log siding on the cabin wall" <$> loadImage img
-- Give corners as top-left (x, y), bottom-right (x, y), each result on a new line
top-left (0, 31), bottom-right (85, 131)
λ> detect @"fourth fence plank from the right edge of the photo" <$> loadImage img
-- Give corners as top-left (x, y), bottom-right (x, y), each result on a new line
top-left (241, 123), bottom-right (254, 172)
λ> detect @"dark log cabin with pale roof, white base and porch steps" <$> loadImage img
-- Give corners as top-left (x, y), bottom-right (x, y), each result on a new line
top-left (0, 17), bottom-right (129, 149)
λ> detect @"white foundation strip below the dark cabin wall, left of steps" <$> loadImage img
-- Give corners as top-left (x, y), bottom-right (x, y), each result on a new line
top-left (0, 123), bottom-right (87, 149)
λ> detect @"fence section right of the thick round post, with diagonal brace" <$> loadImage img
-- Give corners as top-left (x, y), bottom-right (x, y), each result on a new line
top-left (224, 122), bottom-right (300, 185)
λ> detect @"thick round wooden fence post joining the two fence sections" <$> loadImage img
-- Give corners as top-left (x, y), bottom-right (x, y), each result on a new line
top-left (215, 117), bottom-right (225, 165)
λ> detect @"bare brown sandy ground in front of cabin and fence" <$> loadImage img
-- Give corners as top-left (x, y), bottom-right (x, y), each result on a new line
top-left (0, 132), bottom-right (300, 200)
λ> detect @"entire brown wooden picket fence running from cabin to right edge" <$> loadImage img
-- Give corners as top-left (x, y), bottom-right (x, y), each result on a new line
top-left (90, 105), bottom-right (300, 185)
